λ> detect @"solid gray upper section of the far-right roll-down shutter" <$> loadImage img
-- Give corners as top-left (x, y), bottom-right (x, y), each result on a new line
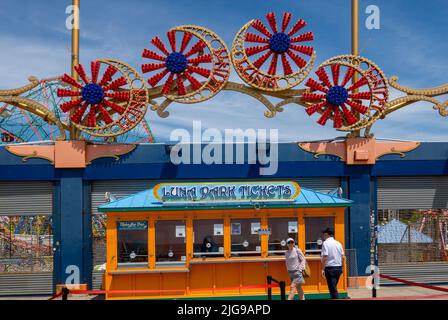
top-left (377, 176), bottom-right (448, 209)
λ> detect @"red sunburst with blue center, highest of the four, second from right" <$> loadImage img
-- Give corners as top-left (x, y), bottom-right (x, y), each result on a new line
top-left (245, 12), bottom-right (314, 76)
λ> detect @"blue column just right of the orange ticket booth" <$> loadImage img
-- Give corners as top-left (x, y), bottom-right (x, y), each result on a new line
top-left (349, 166), bottom-right (373, 275)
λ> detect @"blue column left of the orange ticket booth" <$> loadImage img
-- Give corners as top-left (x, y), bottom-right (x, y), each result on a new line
top-left (53, 169), bottom-right (91, 285)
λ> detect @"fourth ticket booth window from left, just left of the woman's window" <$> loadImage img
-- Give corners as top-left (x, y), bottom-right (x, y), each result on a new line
top-left (230, 219), bottom-right (261, 257)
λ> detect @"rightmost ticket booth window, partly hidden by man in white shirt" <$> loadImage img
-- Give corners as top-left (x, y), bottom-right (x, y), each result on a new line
top-left (305, 217), bottom-right (334, 255)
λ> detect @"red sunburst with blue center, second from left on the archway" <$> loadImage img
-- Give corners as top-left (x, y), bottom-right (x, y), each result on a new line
top-left (142, 31), bottom-right (212, 96)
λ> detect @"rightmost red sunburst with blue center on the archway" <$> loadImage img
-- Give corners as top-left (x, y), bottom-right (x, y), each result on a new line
top-left (302, 63), bottom-right (372, 128)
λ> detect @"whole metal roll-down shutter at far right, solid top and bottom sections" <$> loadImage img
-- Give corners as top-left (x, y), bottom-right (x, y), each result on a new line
top-left (377, 176), bottom-right (448, 285)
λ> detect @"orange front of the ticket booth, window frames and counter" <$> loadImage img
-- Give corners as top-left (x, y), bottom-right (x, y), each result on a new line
top-left (105, 207), bottom-right (347, 299)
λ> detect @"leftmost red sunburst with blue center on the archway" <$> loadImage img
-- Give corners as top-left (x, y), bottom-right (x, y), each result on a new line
top-left (57, 61), bottom-right (130, 127)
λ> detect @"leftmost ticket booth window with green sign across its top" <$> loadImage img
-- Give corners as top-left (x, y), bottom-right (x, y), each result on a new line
top-left (117, 221), bottom-right (148, 265)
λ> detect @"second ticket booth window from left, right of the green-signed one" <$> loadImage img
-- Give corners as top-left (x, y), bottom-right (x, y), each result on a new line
top-left (155, 220), bottom-right (187, 267)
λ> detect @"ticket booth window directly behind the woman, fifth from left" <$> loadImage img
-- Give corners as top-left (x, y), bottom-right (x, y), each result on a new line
top-left (268, 218), bottom-right (299, 255)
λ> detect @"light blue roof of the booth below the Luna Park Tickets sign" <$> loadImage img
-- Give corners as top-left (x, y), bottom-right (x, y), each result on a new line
top-left (98, 188), bottom-right (353, 212)
